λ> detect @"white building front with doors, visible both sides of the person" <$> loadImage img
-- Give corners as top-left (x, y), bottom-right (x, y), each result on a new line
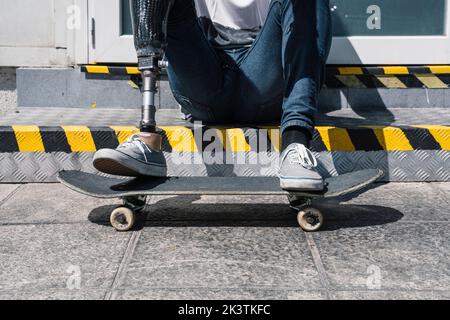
top-left (0, 0), bottom-right (450, 67)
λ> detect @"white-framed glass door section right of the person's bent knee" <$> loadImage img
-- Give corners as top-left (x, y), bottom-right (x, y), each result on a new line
top-left (329, 0), bottom-right (450, 64)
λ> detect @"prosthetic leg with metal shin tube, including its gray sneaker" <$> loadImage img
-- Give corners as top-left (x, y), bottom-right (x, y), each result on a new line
top-left (93, 0), bottom-right (173, 178)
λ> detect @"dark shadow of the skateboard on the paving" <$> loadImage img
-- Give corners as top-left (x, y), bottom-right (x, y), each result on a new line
top-left (88, 192), bottom-right (403, 230)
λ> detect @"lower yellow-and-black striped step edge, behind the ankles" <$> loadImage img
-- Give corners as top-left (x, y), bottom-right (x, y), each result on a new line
top-left (0, 125), bottom-right (450, 153)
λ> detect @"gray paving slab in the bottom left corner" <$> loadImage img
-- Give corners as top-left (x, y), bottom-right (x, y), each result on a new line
top-left (0, 224), bottom-right (130, 297)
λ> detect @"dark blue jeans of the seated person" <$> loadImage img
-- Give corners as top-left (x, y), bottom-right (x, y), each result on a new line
top-left (166, 0), bottom-right (332, 133)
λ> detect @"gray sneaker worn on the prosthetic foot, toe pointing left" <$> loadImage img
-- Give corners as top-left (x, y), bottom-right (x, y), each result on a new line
top-left (94, 135), bottom-right (167, 177)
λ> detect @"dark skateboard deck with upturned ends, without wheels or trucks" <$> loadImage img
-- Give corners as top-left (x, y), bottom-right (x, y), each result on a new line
top-left (58, 169), bottom-right (382, 198)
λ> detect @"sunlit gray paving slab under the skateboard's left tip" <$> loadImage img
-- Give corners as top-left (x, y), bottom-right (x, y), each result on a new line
top-left (0, 184), bottom-right (120, 224)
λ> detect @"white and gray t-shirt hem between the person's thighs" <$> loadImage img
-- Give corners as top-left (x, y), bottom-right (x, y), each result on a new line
top-left (195, 0), bottom-right (271, 49)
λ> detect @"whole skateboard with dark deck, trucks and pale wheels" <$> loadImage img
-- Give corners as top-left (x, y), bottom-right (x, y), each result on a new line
top-left (58, 169), bottom-right (383, 232)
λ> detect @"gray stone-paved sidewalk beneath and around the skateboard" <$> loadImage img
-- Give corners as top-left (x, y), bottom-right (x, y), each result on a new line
top-left (0, 183), bottom-right (450, 299)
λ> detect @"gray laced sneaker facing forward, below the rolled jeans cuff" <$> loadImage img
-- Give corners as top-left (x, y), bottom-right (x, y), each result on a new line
top-left (279, 143), bottom-right (324, 191)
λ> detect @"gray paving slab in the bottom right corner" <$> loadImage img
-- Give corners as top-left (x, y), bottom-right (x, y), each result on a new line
top-left (312, 222), bottom-right (450, 291)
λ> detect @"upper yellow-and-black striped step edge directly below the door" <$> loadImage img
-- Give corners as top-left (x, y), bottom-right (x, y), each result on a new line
top-left (81, 65), bottom-right (450, 89)
